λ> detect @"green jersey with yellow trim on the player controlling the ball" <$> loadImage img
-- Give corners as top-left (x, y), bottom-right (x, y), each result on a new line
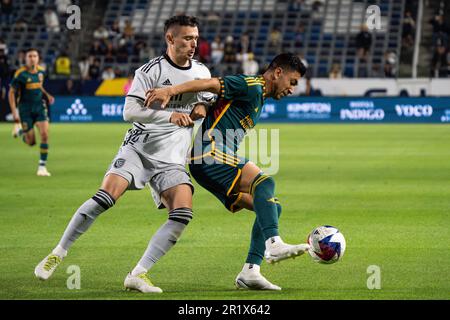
top-left (193, 75), bottom-right (265, 157)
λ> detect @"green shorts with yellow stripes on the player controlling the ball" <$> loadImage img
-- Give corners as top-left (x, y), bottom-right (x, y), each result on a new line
top-left (189, 149), bottom-right (248, 212)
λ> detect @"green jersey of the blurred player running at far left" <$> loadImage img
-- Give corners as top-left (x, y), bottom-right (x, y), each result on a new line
top-left (11, 66), bottom-right (45, 106)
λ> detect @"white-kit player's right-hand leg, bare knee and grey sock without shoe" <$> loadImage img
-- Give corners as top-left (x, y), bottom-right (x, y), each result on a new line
top-left (131, 184), bottom-right (192, 276)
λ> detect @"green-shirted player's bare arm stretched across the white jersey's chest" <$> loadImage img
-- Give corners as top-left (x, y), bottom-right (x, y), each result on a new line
top-left (144, 78), bottom-right (220, 108)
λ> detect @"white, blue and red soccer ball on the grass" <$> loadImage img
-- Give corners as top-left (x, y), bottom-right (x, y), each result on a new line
top-left (308, 226), bottom-right (345, 264)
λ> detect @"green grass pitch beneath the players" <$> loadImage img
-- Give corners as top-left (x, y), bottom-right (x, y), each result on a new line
top-left (0, 124), bottom-right (450, 300)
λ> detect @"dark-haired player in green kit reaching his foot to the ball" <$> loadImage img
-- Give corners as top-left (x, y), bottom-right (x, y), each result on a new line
top-left (145, 53), bottom-right (309, 290)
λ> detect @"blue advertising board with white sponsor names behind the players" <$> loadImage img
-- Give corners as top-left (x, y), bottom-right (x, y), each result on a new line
top-left (50, 96), bottom-right (450, 123)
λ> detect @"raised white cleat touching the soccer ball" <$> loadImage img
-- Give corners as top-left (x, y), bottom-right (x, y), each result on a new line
top-left (264, 237), bottom-right (310, 263)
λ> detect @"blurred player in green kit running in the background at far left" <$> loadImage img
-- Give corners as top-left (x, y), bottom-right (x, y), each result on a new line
top-left (8, 48), bottom-right (55, 176)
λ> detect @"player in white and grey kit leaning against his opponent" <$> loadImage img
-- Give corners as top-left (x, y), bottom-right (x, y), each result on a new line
top-left (35, 16), bottom-right (214, 292)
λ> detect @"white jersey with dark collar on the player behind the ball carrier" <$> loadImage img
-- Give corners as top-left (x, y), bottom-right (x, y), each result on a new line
top-left (123, 54), bottom-right (214, 165)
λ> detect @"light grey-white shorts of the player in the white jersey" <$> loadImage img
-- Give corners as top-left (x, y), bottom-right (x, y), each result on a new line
top-left (105, 146), bottom-right (194, 209)
